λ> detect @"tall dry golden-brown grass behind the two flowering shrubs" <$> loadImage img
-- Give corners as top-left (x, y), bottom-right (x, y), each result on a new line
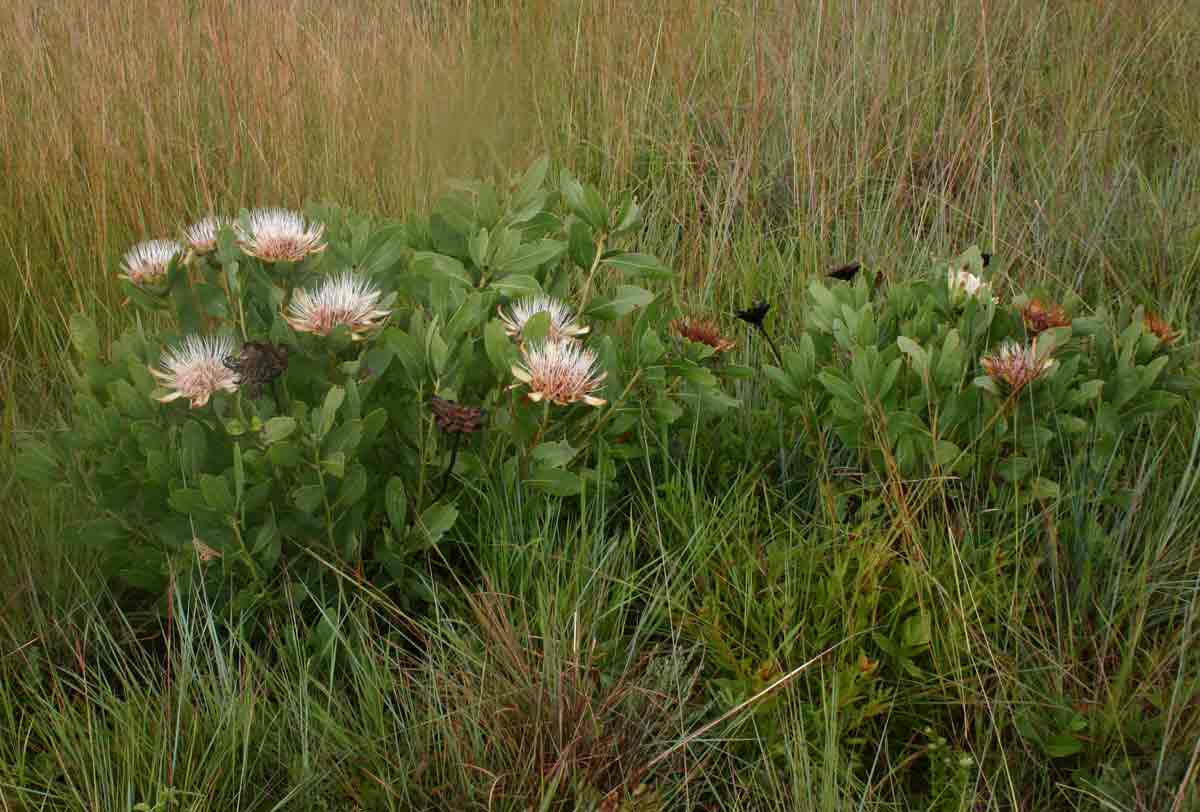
top-left (0, 0), bottom-right (1200, 398)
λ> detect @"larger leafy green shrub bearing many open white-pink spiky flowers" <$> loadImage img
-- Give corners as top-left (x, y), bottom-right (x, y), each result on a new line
top-left (19, 154), bottom-right (748, 616)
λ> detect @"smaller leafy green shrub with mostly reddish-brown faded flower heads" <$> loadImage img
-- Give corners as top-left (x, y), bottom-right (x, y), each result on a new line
top-left (766, 247), bottom-right (1195, 506)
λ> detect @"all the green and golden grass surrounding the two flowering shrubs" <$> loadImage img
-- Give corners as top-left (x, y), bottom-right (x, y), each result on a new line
top-left (0, 0), bottom-right (1200, 812)
